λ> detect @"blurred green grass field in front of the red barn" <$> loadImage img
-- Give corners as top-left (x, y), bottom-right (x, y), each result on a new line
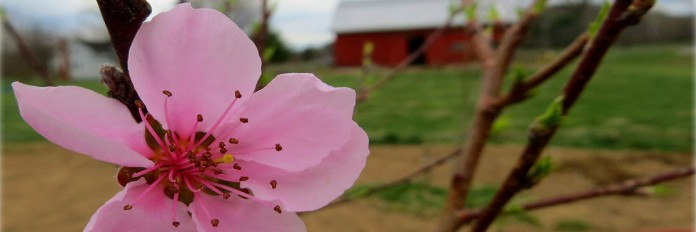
top-left (3, 45), bottom-right (693, 152)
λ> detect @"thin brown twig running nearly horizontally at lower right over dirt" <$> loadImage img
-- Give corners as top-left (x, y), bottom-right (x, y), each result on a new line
top-left (459, 167), bottom-right (694, 223)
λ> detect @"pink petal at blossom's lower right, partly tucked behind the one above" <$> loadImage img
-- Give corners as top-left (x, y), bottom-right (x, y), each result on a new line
top-left (239, 124), bottom-right (370, 212)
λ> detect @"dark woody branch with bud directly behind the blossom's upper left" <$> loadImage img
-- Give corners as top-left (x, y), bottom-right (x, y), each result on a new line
top-left (97, 0), bottom-right (152, 122)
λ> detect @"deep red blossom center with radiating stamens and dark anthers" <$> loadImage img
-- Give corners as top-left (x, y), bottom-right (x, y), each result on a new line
top-left (118, 90), bottom-right (283, 227)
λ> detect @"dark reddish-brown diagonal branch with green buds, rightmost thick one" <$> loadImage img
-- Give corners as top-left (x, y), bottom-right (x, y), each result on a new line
top-left (472, 0), bottom-right (652, 231)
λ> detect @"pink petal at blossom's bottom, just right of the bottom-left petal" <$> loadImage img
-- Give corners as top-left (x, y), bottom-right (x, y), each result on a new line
top-left (190, 194), bottom-right (307, 232)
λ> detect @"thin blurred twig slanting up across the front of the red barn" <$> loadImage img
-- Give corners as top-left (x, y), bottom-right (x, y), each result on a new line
top-left (356, 9), bottom-right (462, 104)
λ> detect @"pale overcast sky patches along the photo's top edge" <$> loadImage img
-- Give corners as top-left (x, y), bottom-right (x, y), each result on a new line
top-left (0, 0), bottom-right (694, 49)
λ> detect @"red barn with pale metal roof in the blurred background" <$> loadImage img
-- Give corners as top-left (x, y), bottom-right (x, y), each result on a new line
top-left (333, 0), bottom-right (511, 66)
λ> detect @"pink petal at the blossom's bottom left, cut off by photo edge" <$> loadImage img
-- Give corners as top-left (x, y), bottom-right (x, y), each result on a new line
top-left (84, 179), bottom-right (196, 232)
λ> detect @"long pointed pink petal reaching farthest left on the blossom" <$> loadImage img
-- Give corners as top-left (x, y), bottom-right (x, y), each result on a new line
top-left (12, 82), bottom-right (153, 167)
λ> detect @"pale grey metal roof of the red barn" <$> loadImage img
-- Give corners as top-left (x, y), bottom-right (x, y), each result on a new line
top-left (333, 0), bottom-right (517, 33)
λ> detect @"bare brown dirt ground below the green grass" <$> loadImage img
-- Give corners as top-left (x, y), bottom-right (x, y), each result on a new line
top-left (2, 143), bottom-right (694, 232)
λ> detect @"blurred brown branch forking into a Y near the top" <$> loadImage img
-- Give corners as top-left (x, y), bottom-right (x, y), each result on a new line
top-left (438, 0), bottom-right (543, 232)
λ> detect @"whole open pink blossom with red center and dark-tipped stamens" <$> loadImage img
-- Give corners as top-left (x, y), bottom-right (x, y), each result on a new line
top-left (12, 4), bottom-right (369, 231)
